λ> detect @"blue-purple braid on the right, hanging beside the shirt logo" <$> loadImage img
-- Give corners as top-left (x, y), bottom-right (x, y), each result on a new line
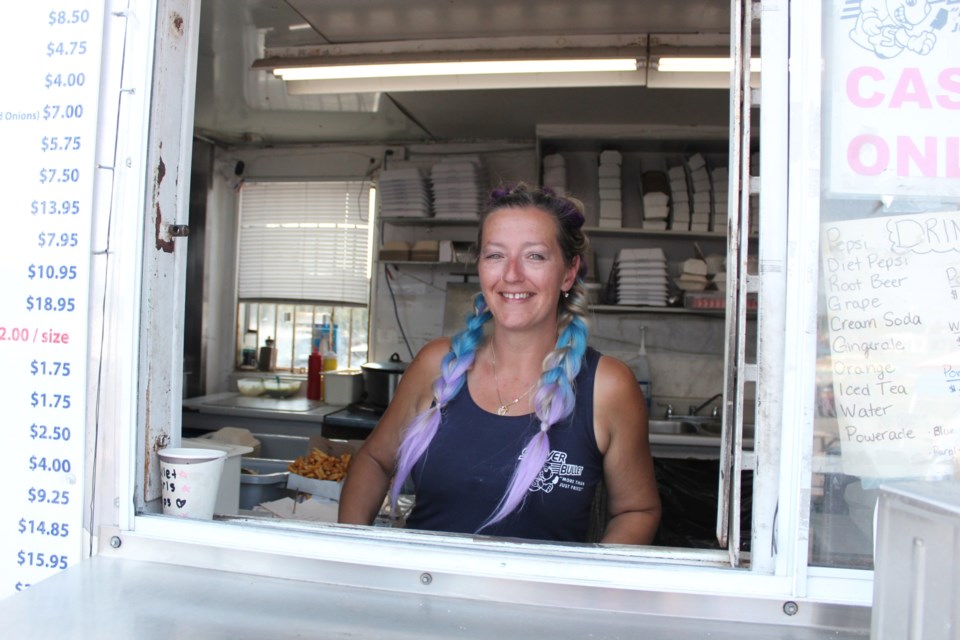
top-left (480, 278), bottom-right (587, 529)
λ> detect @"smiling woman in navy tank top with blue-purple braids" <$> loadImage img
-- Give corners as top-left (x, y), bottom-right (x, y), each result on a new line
top-left (340, 185), bottom-right (660, 544)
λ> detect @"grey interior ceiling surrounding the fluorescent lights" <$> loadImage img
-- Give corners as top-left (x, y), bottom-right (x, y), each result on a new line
top-left (195, 0), bottom-right (730, 146)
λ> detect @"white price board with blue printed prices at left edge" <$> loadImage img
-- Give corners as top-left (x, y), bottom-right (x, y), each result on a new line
top-left (0, 0), bottom-right (105, 598)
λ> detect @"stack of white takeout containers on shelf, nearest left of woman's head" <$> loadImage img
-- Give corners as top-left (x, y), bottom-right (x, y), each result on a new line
top-left (430, 156), bottom-right (487, 220)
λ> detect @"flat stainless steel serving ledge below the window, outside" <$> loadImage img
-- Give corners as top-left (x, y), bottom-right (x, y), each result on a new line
top-left (0, 556), bottom-right (869, 640)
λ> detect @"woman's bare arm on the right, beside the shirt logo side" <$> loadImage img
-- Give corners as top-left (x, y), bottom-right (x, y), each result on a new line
top-left (593, 356), bottom-right (660, 544)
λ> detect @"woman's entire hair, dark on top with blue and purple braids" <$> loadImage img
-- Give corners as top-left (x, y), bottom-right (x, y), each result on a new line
top-left (390, 184), bottom-right (588, 529)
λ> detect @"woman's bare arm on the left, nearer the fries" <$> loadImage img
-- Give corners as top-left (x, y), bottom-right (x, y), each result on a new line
top-left (338, 338), bottom-right (450, 525)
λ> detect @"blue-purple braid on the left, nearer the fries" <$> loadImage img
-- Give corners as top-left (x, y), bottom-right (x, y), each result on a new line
top-left (390, 293), bottom-right (492, 513)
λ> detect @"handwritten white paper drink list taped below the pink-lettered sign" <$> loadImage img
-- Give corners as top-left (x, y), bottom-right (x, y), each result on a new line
top-left (821, 211), bottom-right (960, 478)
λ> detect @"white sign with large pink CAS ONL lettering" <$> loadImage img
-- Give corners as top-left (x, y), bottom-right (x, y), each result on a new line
top-left (823, 0), bottom-right (960, 197)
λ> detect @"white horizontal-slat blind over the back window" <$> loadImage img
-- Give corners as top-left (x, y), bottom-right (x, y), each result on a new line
top-left (237, 180), bottom-right (371, 305)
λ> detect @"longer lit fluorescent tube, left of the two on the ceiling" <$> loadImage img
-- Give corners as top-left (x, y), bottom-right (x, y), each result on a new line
top-left (273, 58), bottom-right (637, 81)
